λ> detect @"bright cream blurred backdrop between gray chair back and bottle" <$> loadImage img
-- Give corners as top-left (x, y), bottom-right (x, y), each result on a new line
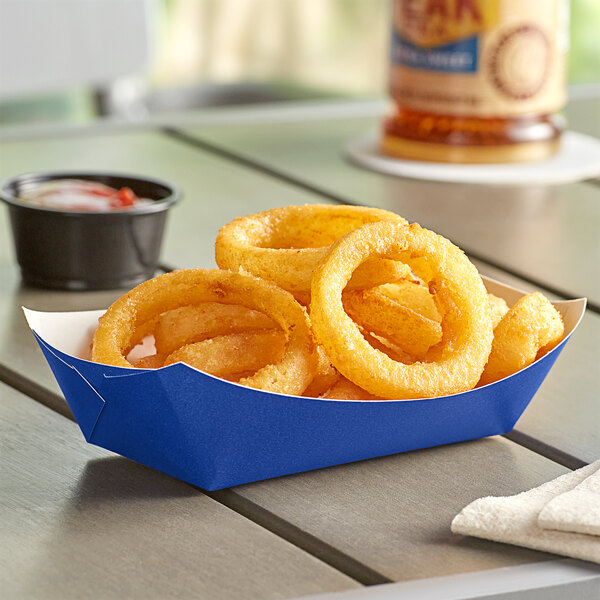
top-left (153, 0), bottom-right (389, 95)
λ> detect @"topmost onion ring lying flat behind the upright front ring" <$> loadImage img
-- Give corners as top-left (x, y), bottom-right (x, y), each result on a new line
top-left (215, 204), bottom-right (410, 293)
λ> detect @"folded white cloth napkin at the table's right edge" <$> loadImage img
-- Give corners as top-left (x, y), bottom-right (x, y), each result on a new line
top-left (452, 460), bottom-right (600, 563)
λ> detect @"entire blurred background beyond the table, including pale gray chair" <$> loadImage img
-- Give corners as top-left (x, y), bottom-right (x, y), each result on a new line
top-left (0, 0), bottom-right (600, 127)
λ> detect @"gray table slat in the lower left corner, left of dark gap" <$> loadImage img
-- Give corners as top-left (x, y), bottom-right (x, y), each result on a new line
top-left (0, 384), bottom-right (360, 599)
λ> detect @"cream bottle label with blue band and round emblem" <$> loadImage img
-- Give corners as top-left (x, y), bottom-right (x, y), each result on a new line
top-left (390, 0), bottom-right (568, 117)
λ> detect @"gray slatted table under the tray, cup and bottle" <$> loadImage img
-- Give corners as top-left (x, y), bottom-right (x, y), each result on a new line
top-left (0, 99), bottom-right (600, 600)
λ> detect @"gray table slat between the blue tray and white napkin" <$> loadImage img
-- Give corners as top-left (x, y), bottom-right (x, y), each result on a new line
top-left (233, 438), bottom-right (567, 581)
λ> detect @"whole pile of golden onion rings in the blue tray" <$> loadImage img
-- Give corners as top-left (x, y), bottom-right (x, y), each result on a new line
top-left (92, 205), bottom-right (564, 400)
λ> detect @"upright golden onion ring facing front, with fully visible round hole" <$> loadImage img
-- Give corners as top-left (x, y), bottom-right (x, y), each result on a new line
top-left (311, 221), bottom-right (492, 399)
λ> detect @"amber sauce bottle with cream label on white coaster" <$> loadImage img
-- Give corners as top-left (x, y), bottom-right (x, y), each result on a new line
top-left (381, 0), bottom-right (568, 163)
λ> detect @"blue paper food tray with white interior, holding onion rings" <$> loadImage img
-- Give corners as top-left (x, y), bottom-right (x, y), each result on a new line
top-left (24, 278), bottom-right (585, 490)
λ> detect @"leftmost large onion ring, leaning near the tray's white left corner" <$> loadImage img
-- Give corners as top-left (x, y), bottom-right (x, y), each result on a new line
top-left (92, 269), bottom-right (317, 395)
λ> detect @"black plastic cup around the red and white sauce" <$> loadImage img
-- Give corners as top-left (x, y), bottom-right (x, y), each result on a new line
top-left (0, 172), bottom-right (180, 290)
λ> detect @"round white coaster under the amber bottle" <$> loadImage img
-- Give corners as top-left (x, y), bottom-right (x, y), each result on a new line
top-left (345, 131), bottom-right (600, 185)
